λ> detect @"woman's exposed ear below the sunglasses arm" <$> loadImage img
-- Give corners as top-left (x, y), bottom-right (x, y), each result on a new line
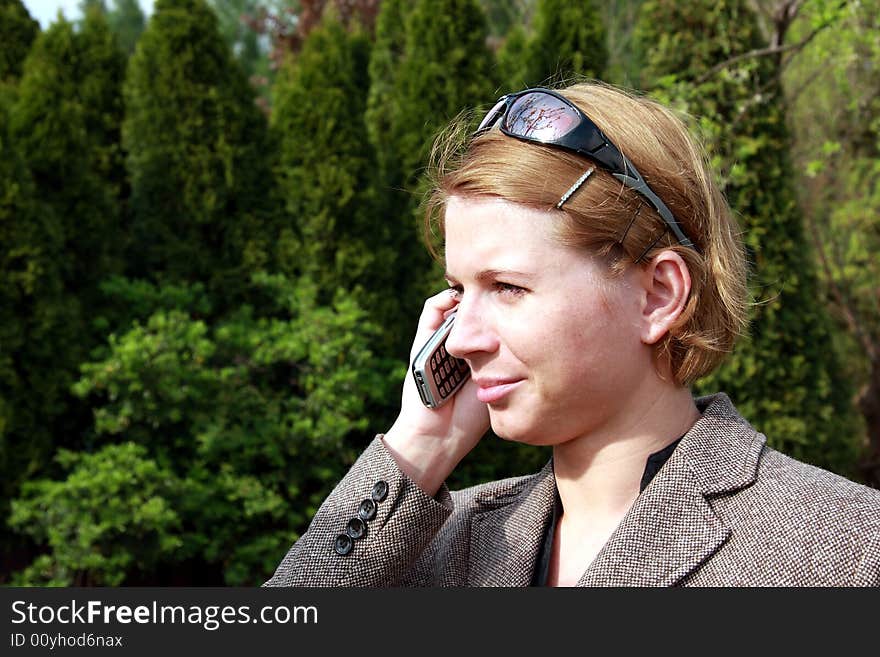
top-left (641, 250), bottom-right (691, 344)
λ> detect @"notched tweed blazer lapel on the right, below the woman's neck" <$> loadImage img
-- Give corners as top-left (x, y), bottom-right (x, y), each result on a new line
top-left (578, 395), bottom-right (764, 586)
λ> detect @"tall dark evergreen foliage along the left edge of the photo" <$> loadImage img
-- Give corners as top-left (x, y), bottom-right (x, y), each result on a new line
top-left (0, 14), bottom-right (123, 564)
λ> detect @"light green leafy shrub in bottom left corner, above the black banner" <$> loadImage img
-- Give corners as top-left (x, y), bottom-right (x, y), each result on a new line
top-left (10, 442), bottom-right (183, 586)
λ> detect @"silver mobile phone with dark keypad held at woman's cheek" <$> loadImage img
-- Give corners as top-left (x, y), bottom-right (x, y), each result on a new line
top-left (412, 312), bottom-right (471, 408)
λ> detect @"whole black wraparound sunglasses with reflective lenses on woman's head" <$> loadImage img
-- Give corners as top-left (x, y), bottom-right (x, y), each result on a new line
top-left (475, 88), bottom-right (697, 251)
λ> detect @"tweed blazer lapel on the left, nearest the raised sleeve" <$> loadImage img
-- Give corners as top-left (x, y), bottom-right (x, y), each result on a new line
top-left (468, 463), bottom-right (556, 586)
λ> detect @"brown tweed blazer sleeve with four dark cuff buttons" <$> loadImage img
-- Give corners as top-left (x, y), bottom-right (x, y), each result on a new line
top-left (264, 435), bottom-right (453, 587)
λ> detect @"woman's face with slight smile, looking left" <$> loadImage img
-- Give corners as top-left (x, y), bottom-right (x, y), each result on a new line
top-left (445, 192), bottom-right (654, 445)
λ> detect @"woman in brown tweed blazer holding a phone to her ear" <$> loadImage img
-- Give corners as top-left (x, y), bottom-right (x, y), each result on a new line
top-left (268, 84), bottom-right (880, 586)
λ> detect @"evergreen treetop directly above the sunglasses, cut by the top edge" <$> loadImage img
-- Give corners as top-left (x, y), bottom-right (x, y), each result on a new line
top-left (526, 0), bottom-right (608, 86)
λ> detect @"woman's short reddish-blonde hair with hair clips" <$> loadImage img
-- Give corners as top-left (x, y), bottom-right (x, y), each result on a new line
top-left (425, 83), bottom-right (748, 385)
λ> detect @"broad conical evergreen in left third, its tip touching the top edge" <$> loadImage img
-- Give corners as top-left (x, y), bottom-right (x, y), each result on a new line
top-left (123, 0), bottom-right (275, 310)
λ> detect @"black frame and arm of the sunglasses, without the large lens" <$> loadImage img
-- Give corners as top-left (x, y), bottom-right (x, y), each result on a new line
top-left (474, 87), bottom-right (699, 253)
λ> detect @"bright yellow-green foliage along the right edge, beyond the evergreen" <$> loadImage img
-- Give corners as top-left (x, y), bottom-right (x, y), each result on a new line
top-left (785, 1), bottom-right (880, 485)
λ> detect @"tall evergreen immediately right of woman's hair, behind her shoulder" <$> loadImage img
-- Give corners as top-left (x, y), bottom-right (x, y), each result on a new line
top-left (638, 0), bottom-right (858, 472)
